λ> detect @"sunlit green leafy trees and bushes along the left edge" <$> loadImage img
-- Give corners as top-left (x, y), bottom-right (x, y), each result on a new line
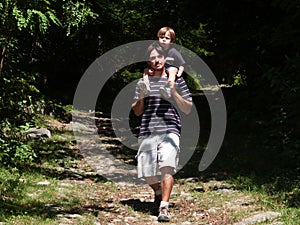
top-left (0, 0), bottom-right (96, 170)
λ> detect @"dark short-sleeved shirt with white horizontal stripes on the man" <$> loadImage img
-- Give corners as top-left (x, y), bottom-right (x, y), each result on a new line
top-left (134, 75), bottom-right (192, 136)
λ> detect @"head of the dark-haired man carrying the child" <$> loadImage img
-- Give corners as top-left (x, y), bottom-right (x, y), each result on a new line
top-left (146, 42), bottom-right (166, 70)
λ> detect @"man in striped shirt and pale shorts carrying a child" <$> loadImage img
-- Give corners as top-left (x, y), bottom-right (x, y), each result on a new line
top-left (132, 42), bottom-right (192, 222)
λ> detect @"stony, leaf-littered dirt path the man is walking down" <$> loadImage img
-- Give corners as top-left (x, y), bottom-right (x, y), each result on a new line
top-left (43, 113), bottom-right (283, 225)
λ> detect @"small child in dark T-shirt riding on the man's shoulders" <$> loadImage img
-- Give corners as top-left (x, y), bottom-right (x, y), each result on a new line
top-left (140, 27), bottom-right (185, 98)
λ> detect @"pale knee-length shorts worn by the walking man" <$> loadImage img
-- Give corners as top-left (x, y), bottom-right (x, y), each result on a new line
top-left (137, 133), bottom-right (179, 178)
